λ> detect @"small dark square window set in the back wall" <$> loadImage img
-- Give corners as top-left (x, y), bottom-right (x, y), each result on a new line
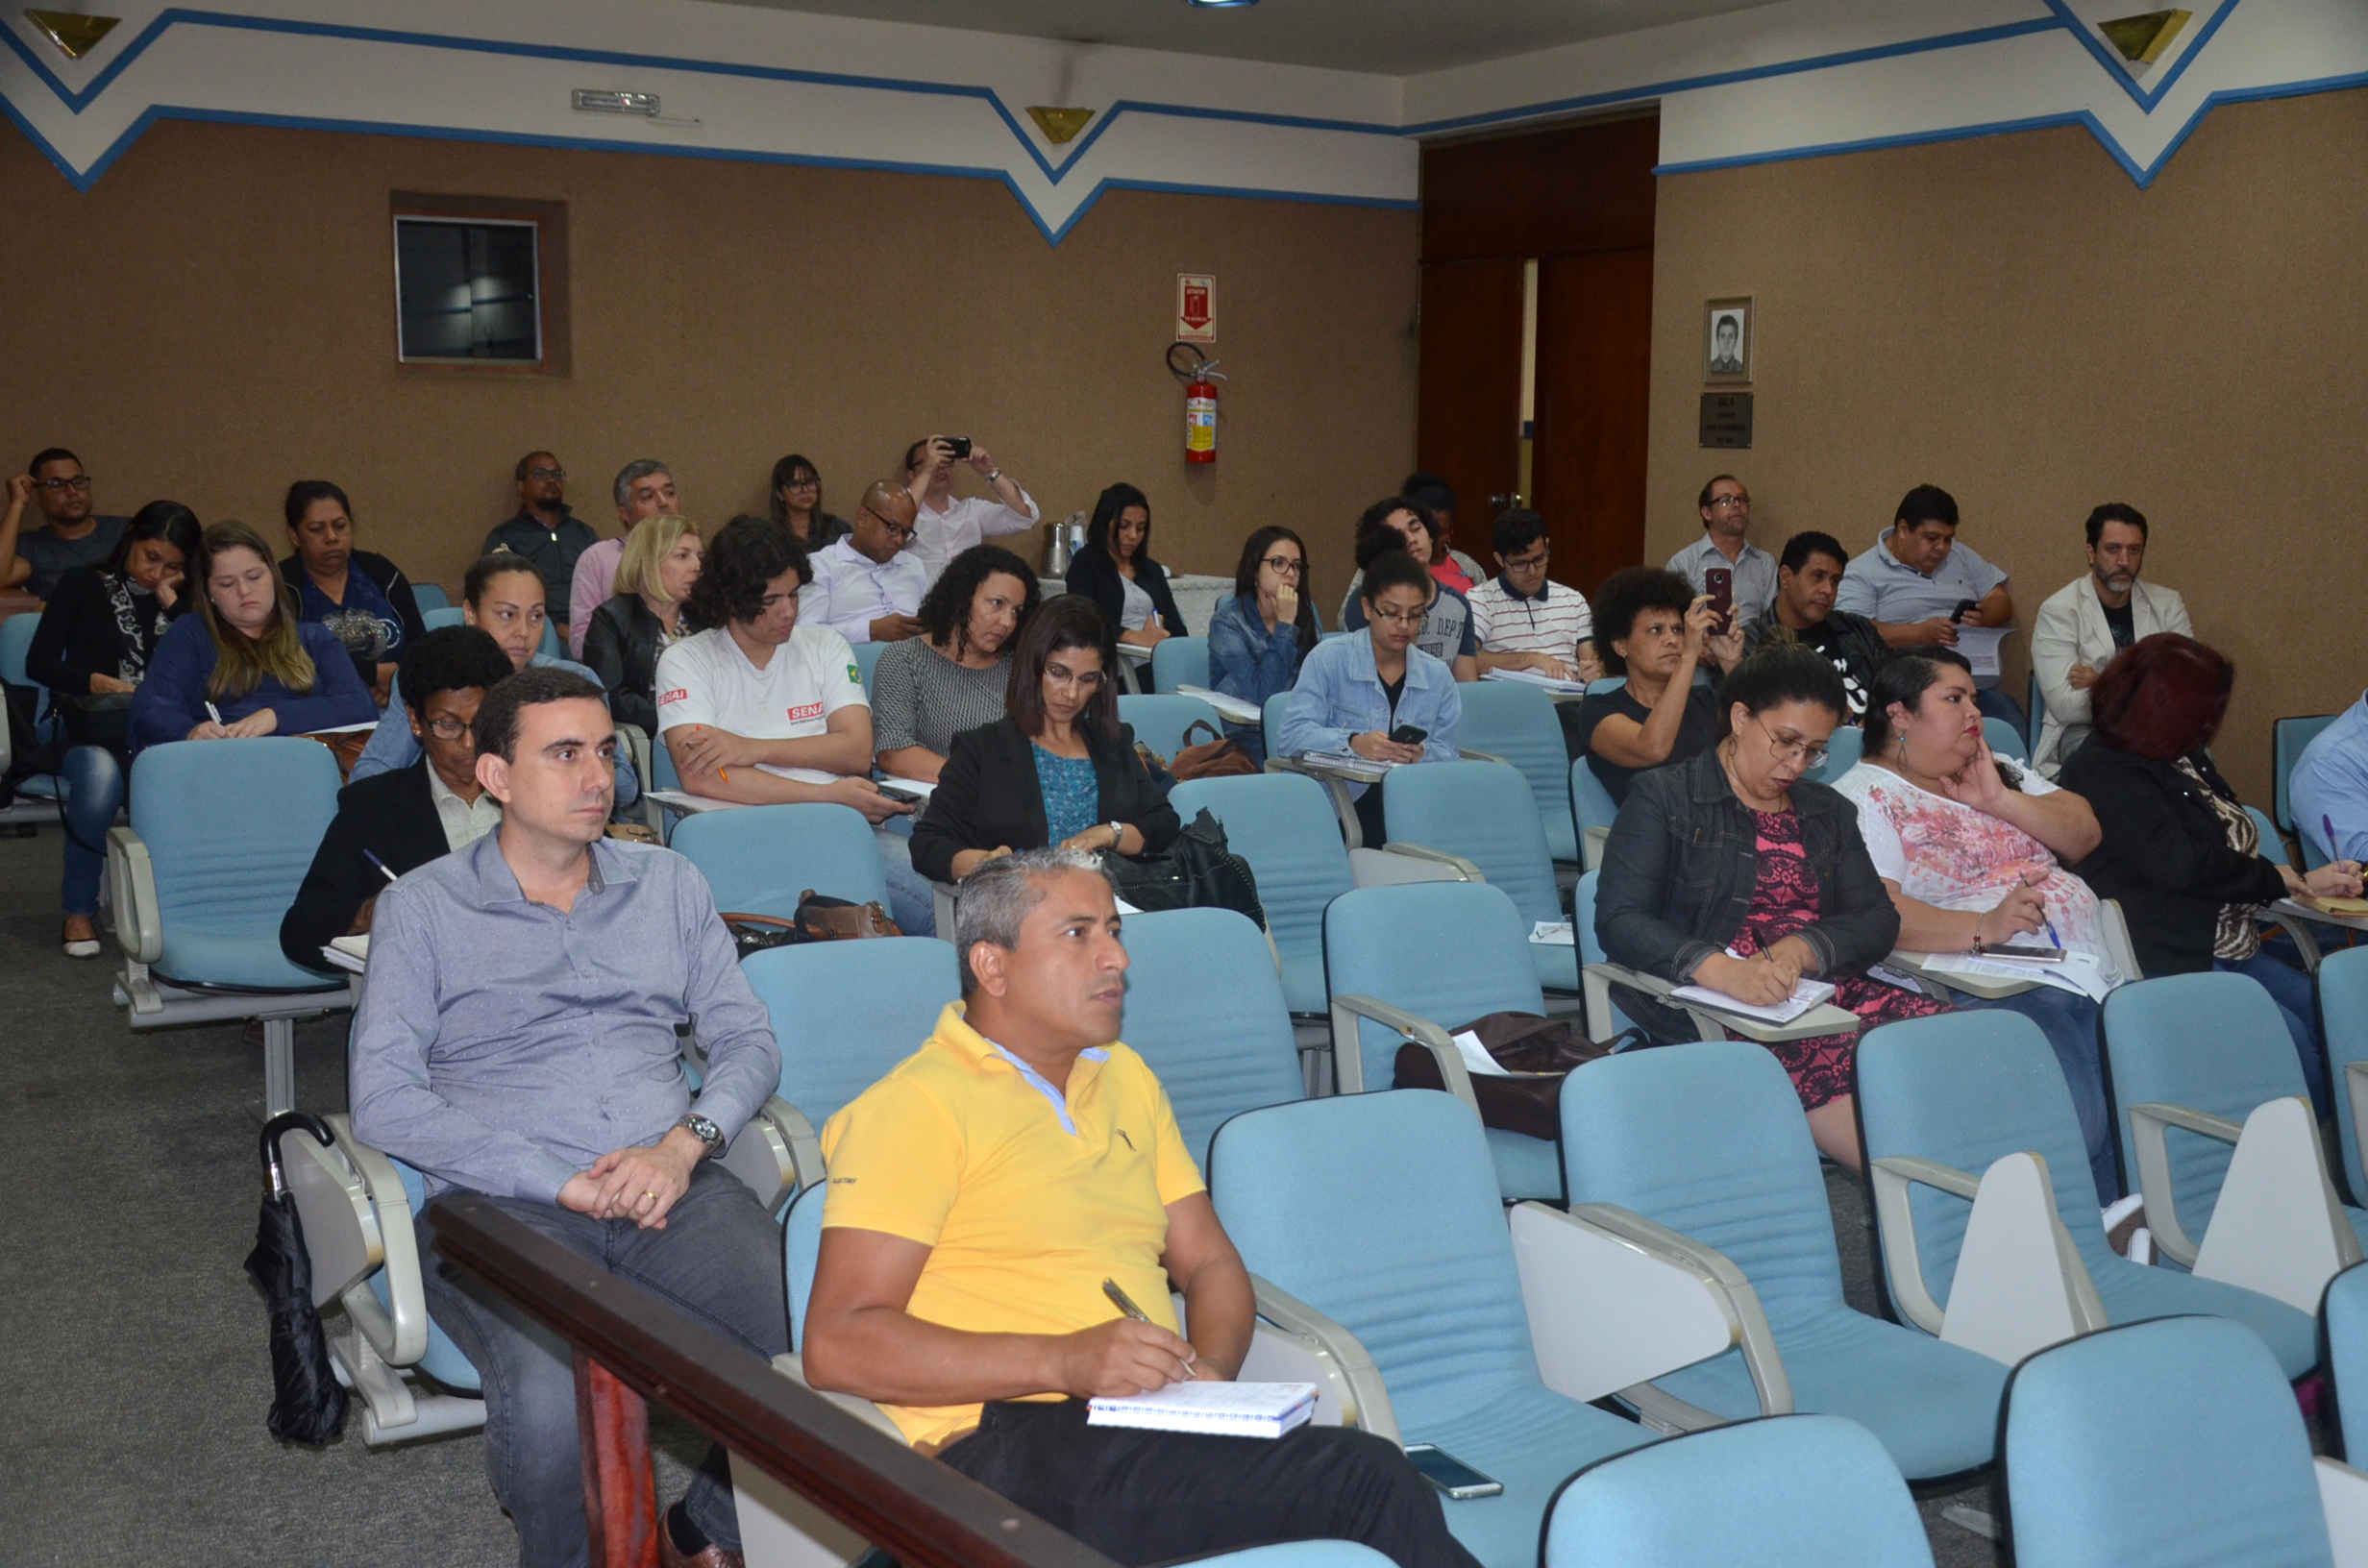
top-left (393, 192), bottom-right (568, 375)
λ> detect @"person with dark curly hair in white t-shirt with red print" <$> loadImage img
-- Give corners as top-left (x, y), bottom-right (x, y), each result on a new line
top-left (658, 519), bottom-right (935, 936)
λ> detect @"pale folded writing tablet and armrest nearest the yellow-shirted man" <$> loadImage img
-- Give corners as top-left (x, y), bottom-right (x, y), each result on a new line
top-left (1511, 1203), bottom-right (1792, 1416)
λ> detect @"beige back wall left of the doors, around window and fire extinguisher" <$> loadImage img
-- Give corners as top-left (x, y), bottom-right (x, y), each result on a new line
top-left (0, 123), bottom-right (1416, 630)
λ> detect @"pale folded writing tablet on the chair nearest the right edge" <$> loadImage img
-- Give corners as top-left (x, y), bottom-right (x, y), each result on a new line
top-left (2178, 1094), bottom-right (2361, 1317)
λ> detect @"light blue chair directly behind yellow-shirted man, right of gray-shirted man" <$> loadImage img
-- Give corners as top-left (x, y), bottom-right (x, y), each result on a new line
top-left (727, 936), bottom-right (961, 1196)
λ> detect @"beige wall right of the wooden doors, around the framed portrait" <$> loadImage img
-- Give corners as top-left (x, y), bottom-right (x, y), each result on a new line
top-left (1645, 92), bottom-right (2368, 808)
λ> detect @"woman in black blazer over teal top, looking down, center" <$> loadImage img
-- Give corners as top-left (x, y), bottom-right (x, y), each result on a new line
top-left (912, 595), bottom-right (1179, 881)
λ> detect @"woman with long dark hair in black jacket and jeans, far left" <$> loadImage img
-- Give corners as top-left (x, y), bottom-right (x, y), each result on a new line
top-left (24, 500), bottom-right (204, 959)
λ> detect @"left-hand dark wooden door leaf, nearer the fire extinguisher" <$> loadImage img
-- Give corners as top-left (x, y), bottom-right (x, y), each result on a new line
top-left (1414, 258), bottom-right (1522, 571)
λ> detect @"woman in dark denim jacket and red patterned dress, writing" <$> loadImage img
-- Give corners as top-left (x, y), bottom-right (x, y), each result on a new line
top-left (1596, 645), bottom-right (1946, 1170)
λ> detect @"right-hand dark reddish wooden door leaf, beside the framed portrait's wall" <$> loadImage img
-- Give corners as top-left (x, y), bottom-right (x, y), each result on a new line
top-left (1524, 249), bottom-right (1653, 595)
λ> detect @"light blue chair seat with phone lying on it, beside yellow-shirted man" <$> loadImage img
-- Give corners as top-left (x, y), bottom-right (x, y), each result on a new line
top-left (1399, 1392), bottom-right (1655, 1568)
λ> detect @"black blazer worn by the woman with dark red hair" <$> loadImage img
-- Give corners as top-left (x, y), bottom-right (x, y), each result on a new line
top-left (2058, 739), bottom-right (2285, 973)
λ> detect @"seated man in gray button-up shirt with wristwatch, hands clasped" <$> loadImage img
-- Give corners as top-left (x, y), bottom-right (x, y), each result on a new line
top-left (351, 668), bottom-right (789, 1566)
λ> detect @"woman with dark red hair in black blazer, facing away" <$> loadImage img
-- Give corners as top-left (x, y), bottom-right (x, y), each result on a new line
top-left (2062, 632), bottom-right (2361, 1115)
